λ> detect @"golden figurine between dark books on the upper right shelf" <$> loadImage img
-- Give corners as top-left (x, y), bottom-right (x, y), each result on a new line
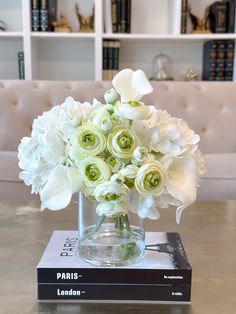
top-left (188, 5), bottom-right (211, 34)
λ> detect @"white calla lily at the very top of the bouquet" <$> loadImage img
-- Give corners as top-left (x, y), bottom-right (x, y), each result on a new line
top-left (112, 69), bottom-right (153, 101)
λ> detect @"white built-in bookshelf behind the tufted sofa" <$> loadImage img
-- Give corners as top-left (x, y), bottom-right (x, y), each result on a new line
top-left (0, 0), bottom-right (236, 80)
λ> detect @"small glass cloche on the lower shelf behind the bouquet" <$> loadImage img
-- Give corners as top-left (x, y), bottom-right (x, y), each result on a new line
top-left (150, 53), bottom-right (173, 81)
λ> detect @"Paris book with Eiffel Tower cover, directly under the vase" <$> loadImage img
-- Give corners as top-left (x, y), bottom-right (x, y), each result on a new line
top-left (37, 231), bottom-right (192, 285)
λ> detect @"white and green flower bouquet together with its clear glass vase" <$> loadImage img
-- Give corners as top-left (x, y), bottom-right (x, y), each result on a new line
top-left (18, 69), bottom-right (204, 266)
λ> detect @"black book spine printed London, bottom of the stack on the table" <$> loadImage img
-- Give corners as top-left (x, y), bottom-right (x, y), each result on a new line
top-left (38, 284), bottom-right (191, 302)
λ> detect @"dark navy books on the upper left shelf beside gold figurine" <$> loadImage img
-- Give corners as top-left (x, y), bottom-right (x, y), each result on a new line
top-left (31, 0), bottom-right (57, 32)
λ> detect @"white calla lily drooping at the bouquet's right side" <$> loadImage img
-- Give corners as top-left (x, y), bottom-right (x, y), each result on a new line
top-left (166, 157), bottom-right (197, 223)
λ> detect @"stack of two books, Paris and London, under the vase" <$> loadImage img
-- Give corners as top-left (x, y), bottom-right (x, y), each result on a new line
top-left (37, 231), bottom-right (192, 303)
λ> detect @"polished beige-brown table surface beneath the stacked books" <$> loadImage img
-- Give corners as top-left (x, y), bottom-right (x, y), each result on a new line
top-left (0, 200), bottom-right (236, 314)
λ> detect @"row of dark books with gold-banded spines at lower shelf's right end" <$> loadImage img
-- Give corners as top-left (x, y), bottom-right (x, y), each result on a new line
top-left (202, 40), bottom-right (235, 81)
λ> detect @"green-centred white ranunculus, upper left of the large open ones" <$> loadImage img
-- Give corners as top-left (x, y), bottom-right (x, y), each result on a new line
top-left (76, 125), bottom-right (106, 156)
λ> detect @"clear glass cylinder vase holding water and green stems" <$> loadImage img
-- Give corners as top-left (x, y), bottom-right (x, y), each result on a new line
top-left (78, 193), bottom-right (145, 266)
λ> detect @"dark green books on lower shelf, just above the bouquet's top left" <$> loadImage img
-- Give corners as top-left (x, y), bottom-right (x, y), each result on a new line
top-left (102, 40), bottom-right (120, 81)
